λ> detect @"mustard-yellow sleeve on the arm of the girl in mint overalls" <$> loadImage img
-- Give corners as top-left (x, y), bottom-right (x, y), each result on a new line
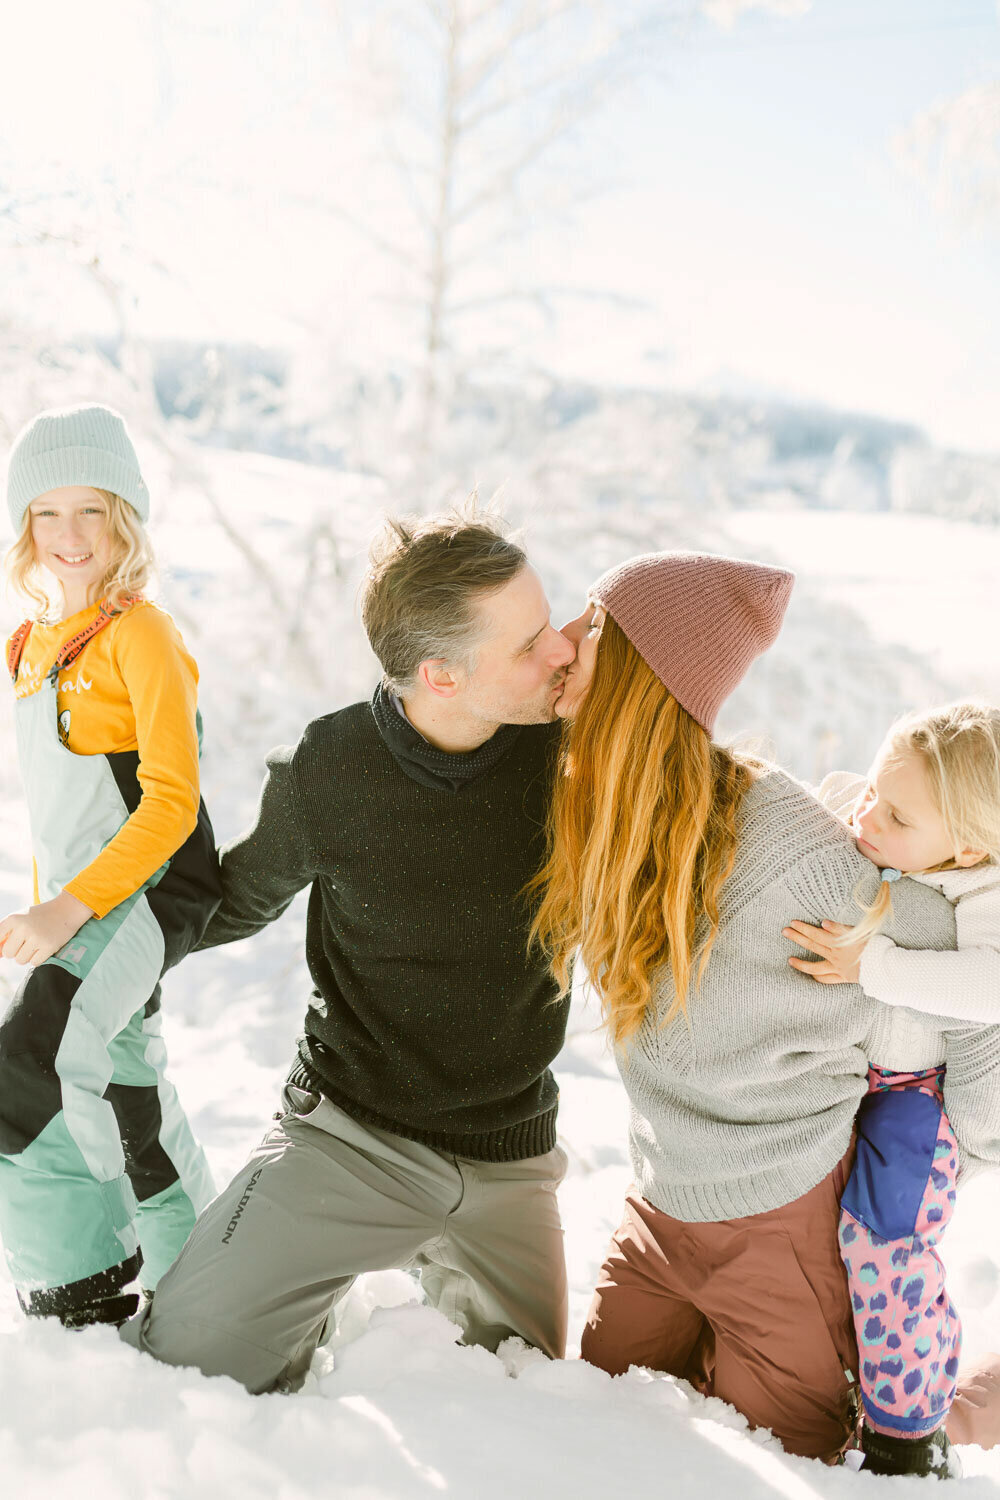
top-left (66, 605), bottom-right (199, 917)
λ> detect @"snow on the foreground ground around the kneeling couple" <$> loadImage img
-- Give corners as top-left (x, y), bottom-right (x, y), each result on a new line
top-left (0, 984), bottom-right (1000, 1500)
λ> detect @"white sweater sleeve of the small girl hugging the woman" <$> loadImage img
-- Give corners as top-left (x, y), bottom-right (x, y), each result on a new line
top-left (861, 890), bottom-right (1000, 1026)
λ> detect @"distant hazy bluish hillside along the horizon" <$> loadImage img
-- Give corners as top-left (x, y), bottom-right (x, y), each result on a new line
top-left (134, 342), bottom-right (1000, 524)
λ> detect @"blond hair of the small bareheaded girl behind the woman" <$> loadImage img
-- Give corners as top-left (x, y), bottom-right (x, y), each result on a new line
top-left (841, 699), bottom-right (1000, 942)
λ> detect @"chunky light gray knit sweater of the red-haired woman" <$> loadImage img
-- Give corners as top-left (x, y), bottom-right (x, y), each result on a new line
top-left (618, 770), bottom-right (1000, 1221)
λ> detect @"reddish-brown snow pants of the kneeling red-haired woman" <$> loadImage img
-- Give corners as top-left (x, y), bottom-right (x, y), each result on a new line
top-left (580, 1149), bottom-right (858, 1460)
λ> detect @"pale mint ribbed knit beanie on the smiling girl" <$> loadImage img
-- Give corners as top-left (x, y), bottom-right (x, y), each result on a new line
top-left (7, 405), bottom-right (150, 537)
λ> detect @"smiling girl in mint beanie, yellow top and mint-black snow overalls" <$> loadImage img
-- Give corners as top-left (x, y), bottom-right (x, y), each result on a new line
top-left (0, 405), bottom-right (220, 1326)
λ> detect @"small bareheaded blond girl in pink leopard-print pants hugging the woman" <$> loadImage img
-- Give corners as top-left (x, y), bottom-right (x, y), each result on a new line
top-left (784, 702), bottom-right (1000, 1475)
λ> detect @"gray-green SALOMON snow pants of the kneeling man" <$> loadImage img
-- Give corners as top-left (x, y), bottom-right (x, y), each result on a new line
top-left (121, 1085), bottom-right (567, 1394)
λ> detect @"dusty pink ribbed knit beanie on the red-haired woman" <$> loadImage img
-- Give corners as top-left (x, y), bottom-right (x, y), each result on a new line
top-left (589, 552), bottom-right (795, 735)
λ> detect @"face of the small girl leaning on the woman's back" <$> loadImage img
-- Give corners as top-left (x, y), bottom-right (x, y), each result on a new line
top-left (852, 746), bottom-right (985, 875)
